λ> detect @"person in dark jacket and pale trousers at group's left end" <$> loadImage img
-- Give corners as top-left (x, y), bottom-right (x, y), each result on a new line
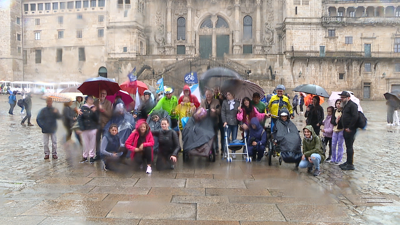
top-left (36, 98), bottom-right (61, 159)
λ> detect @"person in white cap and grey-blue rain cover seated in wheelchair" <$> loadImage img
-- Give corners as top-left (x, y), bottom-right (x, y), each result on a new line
top-left (272, 109), bottom-right (302, 168)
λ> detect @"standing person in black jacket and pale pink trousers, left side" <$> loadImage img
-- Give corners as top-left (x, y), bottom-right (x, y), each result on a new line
top-left (78, 96), bottom-right (100, 163)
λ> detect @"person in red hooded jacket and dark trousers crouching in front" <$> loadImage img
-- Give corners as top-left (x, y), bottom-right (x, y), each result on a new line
top-left (125, 119), bottom-right (154, 174)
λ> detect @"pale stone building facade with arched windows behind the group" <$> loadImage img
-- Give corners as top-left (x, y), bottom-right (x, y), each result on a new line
top-left (0, 0), bottom-right (400, 99)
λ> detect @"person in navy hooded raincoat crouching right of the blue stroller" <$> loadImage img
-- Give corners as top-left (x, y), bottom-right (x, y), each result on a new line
top-left (247, 117), bottom-right (267, 161)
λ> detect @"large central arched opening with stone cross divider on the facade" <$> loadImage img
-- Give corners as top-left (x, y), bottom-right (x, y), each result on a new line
top-left (198, 16), bottom-right (230, 59)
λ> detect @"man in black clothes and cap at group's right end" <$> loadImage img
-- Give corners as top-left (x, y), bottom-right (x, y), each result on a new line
top-left (339, 91), bottom-right (358, 170)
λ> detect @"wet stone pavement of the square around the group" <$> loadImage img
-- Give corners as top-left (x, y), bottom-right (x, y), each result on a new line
top-left (0, 96), bottom-right (400, 225)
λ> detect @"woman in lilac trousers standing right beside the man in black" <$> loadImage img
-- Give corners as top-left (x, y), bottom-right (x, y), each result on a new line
top-left (331, 99), bottom-right (344, 164)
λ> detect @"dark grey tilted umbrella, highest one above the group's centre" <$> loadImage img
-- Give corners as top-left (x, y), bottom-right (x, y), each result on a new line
top-left (200, 67), bottom-right (243, 95)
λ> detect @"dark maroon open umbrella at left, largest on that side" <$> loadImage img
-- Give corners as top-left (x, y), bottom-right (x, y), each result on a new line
top-left (78, 77), bottom-right (121, 97)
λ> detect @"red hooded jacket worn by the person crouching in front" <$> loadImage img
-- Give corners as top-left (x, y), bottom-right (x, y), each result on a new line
top-left (125, 120), bottom-right (154, 160)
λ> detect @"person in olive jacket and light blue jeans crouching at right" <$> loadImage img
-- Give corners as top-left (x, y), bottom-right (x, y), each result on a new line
top-left (299, 125), bottom-right (325, 176)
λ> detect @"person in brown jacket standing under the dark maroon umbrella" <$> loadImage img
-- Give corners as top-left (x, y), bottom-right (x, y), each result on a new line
top-left (94, 90), bottom-right (113, 160)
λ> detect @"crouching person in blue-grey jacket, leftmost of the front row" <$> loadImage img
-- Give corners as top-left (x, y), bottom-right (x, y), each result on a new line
top-left (100, 124), bottom-right (123, 171)
